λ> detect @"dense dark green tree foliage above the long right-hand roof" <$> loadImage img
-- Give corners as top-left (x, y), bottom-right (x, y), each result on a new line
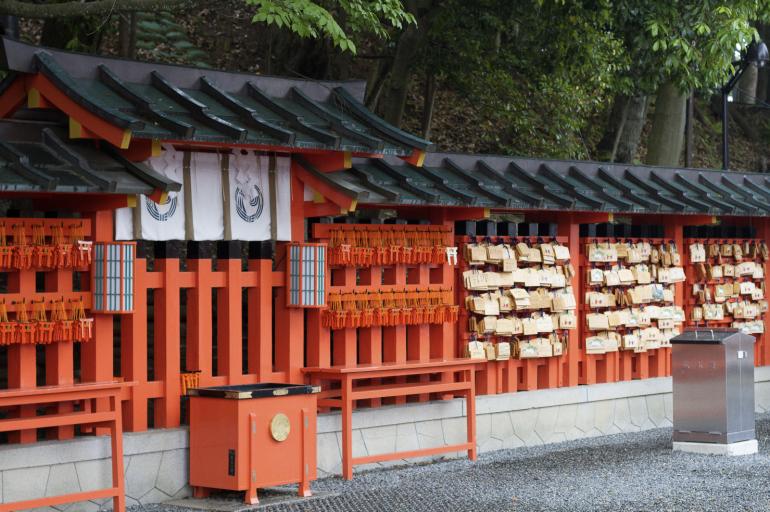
top-left (423, 0), bottom-right (629, 158)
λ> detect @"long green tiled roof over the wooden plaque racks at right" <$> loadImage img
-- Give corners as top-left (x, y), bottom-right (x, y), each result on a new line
top-left (314, 153), bottom-right (770, 216)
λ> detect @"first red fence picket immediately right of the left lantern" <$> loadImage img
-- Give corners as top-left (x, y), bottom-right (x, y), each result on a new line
top-left (120, 252), bottom-right (148, 432)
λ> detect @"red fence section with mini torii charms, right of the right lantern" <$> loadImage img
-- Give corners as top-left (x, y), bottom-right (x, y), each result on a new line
top-left (306, 222), bottom-right (456, 405)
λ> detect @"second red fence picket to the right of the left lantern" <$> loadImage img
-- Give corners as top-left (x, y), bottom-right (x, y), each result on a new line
top-left (154, 242), bottom-right (181, 428)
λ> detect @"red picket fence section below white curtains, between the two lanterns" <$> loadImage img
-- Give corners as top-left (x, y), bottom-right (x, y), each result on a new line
top-left (120, 243), bottom-right (292, 431)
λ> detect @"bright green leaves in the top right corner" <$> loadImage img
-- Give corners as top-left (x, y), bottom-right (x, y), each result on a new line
top-left (560, 0), bottom-right (770, 93)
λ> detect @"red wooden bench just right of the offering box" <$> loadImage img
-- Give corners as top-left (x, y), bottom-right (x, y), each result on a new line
top-left (303, 359), bottom-right (476, 480)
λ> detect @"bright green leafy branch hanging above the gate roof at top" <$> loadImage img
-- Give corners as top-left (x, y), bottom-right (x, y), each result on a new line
top-left (245, 0), bottom-right (415, 54)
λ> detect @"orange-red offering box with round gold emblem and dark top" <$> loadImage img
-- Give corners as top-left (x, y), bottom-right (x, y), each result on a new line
top-left (188, 384), bottom-right (319, 504)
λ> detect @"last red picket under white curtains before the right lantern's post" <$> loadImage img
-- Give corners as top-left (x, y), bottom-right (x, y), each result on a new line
top-left (246, 242), bottom-right (273, 382)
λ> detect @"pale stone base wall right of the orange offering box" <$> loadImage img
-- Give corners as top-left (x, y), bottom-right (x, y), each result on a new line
top-left (318, 366), bottom-right (770, 476)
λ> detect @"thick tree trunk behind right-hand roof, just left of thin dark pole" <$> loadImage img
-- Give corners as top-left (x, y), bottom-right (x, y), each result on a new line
top-left (647, 82), bottom-right (687, 167)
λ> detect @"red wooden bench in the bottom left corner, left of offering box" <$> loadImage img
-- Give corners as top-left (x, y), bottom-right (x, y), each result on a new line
top-left (0, 382), bottom-right (131, 512)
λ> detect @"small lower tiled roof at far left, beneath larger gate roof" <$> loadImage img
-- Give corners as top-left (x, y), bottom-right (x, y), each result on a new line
top-left (0, 121), bottom-right (180, 195)
